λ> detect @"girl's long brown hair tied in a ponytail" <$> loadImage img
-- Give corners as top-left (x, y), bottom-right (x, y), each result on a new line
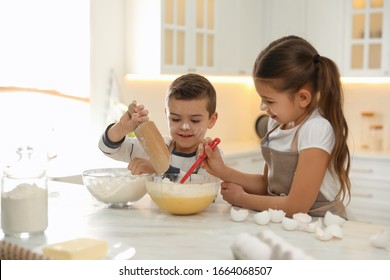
top-left (253, 36), bottom-right (351, 203)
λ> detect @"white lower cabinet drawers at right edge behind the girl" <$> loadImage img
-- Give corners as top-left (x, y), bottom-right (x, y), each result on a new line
top-left (347, 156), bottom-right (390, 225)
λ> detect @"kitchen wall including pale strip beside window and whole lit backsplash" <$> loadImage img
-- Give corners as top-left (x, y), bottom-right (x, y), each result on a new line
top-left (91, 0), bottom-right (390, 156)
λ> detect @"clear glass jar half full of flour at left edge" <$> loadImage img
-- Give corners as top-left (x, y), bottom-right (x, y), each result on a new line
top-left (1, 147), bottom-right (48, 237)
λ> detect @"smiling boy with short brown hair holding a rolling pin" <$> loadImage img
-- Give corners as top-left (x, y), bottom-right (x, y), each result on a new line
top-left (99, 74), bottom-right (218, 175)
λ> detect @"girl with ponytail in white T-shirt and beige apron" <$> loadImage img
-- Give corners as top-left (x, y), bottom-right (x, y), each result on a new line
top-left (203, 36), bottom-right (350, 217)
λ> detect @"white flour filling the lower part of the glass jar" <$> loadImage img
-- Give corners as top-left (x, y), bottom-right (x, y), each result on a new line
top-left (1, 183), bottom-right (48, 234)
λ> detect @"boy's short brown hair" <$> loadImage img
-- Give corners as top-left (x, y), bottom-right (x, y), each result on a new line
top-left (165, 73), bottom-right (217, 117)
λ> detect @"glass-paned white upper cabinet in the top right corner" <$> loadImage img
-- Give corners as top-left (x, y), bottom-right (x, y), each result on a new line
top-left (345, 0), bottom-right (390, 76)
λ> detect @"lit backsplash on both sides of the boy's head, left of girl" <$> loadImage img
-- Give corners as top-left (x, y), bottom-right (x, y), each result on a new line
top-left (122, 77), bottom-right (261, 145)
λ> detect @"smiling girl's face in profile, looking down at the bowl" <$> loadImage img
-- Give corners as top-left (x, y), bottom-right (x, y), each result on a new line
top-left (255, 81), bottom-right (310, 125)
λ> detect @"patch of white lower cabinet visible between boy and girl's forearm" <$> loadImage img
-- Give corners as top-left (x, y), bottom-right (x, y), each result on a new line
top-left (225, 150), bottom-right (265, 174)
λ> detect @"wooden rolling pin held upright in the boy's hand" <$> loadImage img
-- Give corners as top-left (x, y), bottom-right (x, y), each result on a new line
top-left (134, 121), bottom-right (170, 175)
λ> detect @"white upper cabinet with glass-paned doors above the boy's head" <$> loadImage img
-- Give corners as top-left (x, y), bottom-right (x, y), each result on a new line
top-left (125, 0), bottom-right (216, 75)
